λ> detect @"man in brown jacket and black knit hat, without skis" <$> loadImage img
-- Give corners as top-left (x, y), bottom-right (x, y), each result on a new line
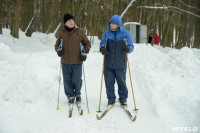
top-left (55, 13), bottom-right (91, 104)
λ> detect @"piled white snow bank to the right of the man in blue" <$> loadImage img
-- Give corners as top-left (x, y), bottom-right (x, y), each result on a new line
top-left (131, 44), bottom-right (200, 128)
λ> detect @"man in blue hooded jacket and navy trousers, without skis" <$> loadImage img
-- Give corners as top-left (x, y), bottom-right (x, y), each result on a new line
top-left (100, 15), bottom-right (134, 106)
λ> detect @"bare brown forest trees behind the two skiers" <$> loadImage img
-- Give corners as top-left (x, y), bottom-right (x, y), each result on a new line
top-left (0, 0), bottom-right (200, 49)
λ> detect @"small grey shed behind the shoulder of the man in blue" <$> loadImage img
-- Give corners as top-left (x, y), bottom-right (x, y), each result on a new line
top-left (123, 22), bottom-right (147, 43)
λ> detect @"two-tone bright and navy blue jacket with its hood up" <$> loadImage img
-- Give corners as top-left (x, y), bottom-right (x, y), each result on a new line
top-left (100, 15), bottom-right (134, 69)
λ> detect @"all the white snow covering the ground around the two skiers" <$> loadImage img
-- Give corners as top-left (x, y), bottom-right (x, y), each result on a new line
top-left (0, 29), bottom-right (200, 133)
